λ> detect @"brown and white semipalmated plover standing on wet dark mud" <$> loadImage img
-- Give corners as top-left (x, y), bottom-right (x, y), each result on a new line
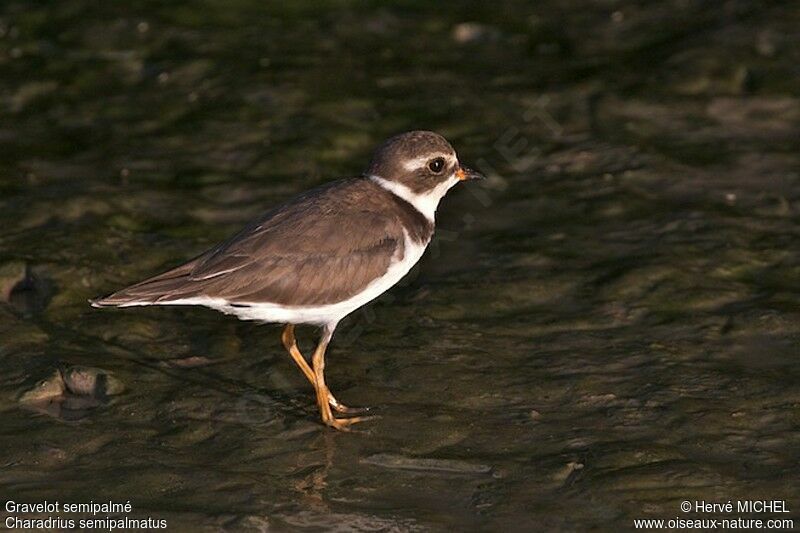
top-left (91, 131), bottom-right (483, 429)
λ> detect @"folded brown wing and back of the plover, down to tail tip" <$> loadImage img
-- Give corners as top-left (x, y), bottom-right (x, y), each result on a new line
top-left (94, 179), bottom-right (404, 306)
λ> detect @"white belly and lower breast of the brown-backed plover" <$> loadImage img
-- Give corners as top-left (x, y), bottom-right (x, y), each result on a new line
top-left (158, 233), bottom-right (428, 325)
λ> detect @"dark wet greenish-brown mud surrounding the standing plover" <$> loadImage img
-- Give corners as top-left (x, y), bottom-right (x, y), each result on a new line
top-left (0, 0), bottom-right (800, 531)
